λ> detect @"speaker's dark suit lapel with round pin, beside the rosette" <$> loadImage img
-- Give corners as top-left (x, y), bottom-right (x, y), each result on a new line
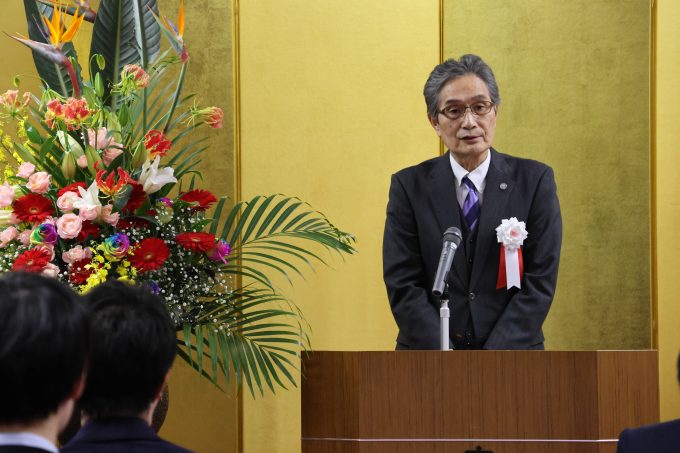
top-left (470, 148), bottom-right (515, 288)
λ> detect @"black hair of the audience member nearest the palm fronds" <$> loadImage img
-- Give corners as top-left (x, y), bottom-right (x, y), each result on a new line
top-left (80, 280), bottom-right (177, 419)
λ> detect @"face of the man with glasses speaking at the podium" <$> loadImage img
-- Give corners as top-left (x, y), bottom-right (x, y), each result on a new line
top-left (430, 74), bottom-right (496, 170)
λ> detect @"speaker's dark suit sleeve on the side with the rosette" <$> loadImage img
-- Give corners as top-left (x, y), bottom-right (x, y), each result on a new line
top-left (484, 167), bottom-right (562, 349)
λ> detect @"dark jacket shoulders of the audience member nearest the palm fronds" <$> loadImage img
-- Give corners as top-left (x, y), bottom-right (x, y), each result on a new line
top-left (61, 418), bottom-right (191, 453)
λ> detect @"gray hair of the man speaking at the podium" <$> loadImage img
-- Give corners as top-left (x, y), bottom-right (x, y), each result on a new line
top-left (423, 54), bottom-right (501, 118)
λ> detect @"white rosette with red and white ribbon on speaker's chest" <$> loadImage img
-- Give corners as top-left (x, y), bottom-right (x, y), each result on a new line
top-left (496, 217), bottom-right (529, 289)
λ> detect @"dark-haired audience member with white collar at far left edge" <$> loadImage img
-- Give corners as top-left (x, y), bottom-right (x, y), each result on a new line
top-left (0, 273), bottom-right (88, 453)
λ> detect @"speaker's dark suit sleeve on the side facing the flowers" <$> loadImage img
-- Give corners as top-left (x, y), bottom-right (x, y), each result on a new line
top-left (383, 175), bottom-right (439, 349)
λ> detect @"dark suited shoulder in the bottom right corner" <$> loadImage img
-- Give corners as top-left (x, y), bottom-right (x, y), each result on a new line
top-left (616, 419), bottom-right (680, 453)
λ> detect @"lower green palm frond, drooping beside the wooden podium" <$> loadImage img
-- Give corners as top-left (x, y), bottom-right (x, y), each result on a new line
top-left (178, 289), bottom-right (309, 396)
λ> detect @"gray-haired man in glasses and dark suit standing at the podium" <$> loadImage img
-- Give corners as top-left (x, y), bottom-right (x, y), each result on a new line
top-left (383, 55), bottom-right (562, 349)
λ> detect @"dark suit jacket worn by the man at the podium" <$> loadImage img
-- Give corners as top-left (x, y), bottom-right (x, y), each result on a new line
top-left (383, 149), bottom-right (562, 349)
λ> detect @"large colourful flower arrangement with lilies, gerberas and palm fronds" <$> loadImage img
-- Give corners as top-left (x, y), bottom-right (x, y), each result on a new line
top-left (0, 0), bottom-right (353, 395)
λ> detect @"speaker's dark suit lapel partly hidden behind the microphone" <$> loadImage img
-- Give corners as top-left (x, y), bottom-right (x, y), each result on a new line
top-left (427, 152), bottom-right (468, 289)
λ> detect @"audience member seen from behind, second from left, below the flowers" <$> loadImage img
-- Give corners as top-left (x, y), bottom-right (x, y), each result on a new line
top-left (62, 281), bottom-right (190, 453)
